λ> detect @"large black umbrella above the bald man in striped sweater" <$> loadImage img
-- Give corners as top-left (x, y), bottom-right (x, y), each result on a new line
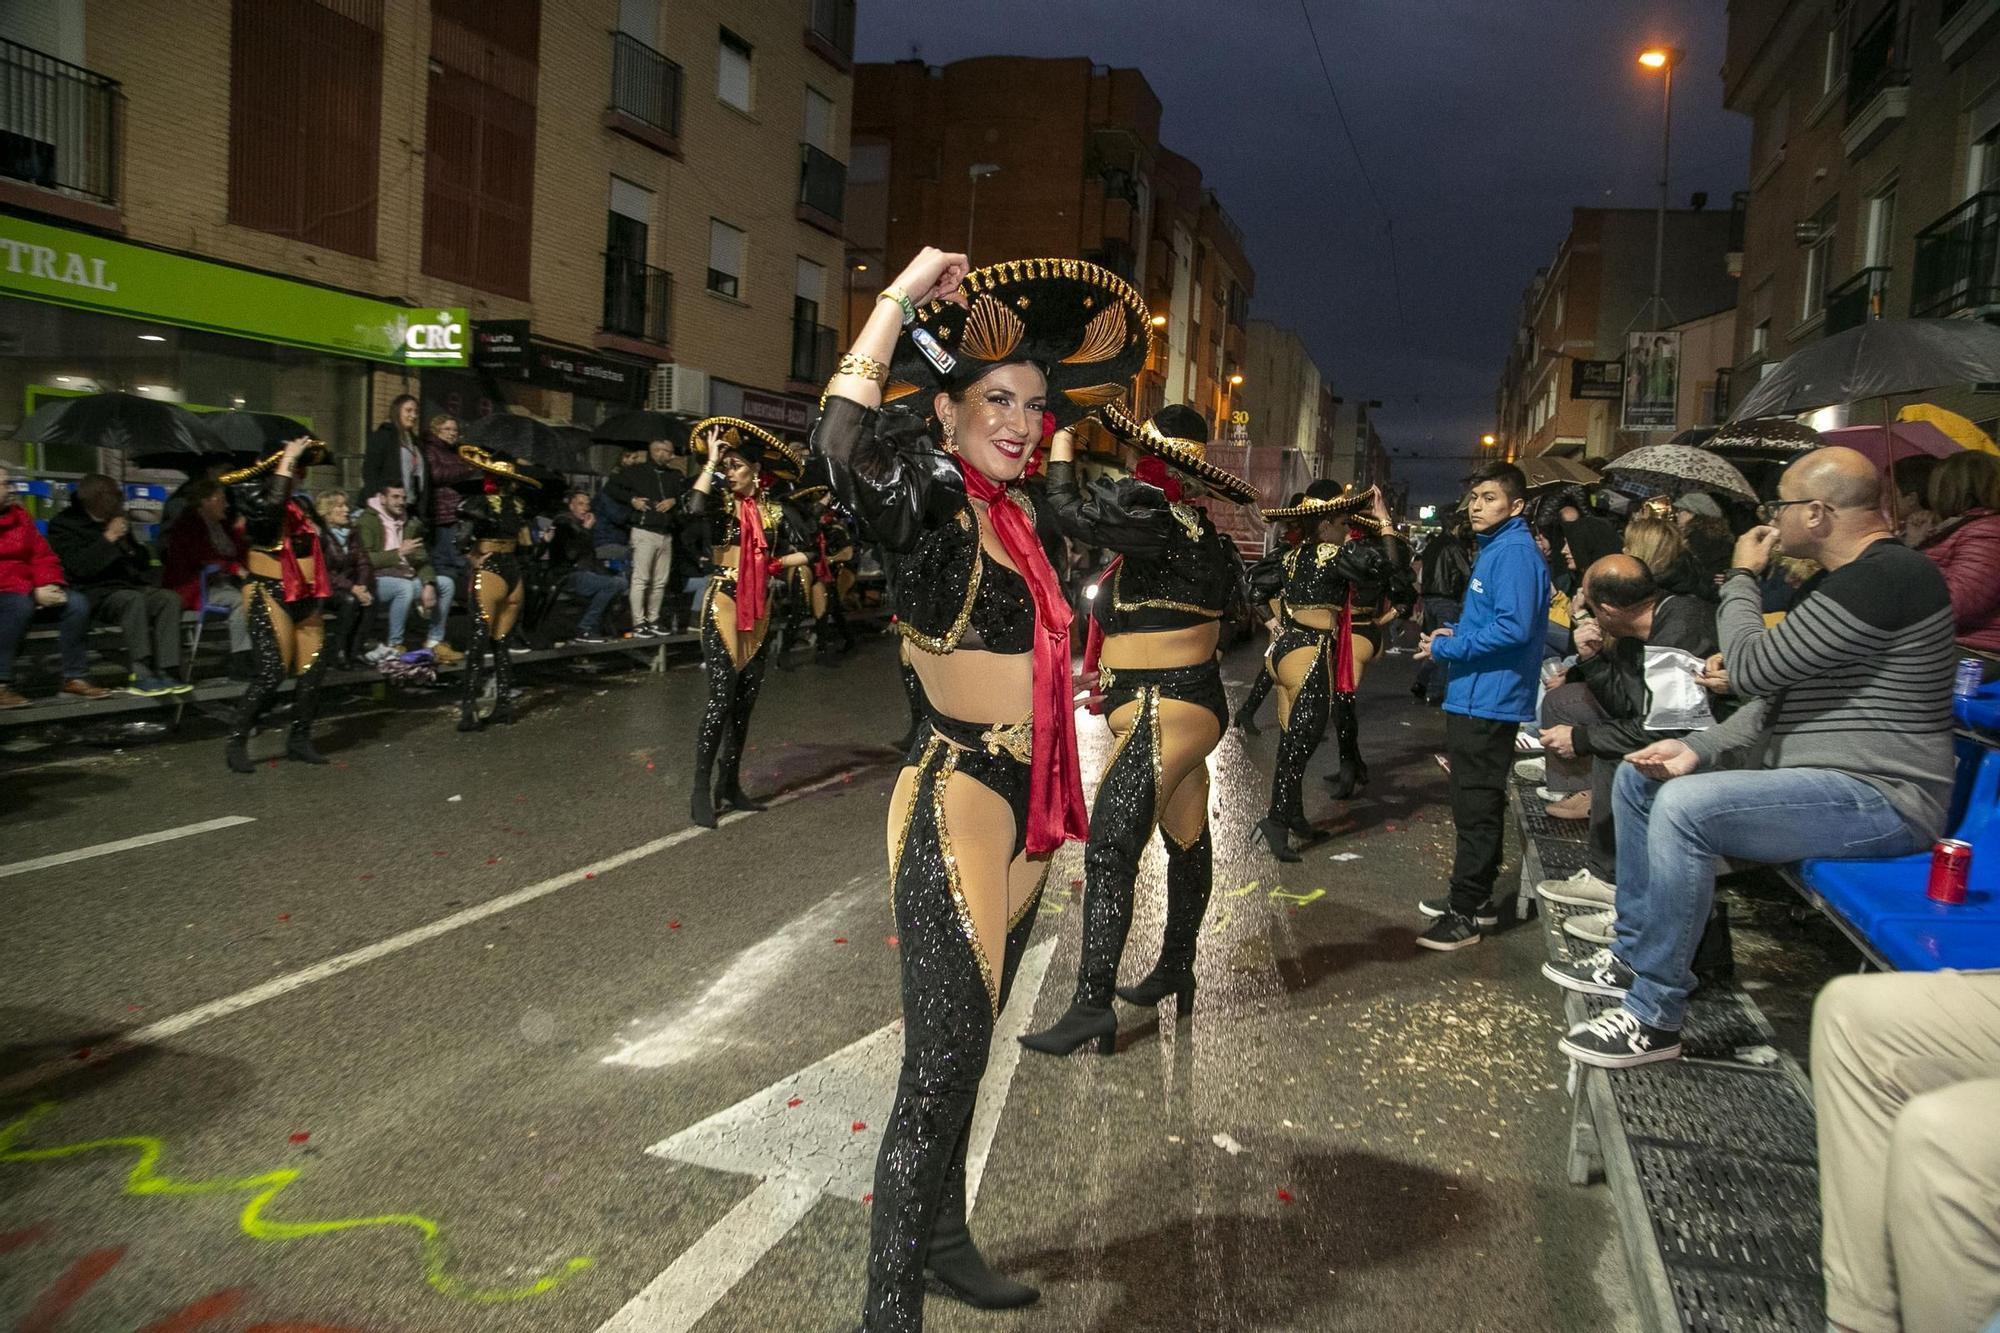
top-left (1730, 320), bottom-right (2000, 420)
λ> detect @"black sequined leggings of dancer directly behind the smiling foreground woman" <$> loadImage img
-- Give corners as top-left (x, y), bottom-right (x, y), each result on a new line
top-left (1074, 660), bottom-right (1230, 1009)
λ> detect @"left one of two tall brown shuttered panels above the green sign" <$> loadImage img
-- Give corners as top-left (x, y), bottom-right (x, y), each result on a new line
top-left (228, 0), bottom-right (382, 258)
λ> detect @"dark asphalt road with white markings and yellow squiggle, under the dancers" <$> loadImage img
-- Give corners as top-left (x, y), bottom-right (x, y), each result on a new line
top-left (0, 640), bottom-right (1628, 1333)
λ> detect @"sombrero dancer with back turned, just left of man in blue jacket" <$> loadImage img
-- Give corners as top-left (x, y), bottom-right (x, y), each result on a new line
top-left (1250, 480), bottom-right (1414, 861)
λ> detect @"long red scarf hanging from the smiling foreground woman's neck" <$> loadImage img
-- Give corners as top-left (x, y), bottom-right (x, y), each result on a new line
top-left (958, 460), bottom-right (1090, 855)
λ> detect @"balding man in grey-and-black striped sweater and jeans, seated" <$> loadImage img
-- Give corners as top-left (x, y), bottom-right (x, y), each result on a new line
top-left (1542, 448), bottom-right (1956, 1069)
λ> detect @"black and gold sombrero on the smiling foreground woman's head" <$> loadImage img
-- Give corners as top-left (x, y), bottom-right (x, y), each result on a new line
top-left (882, 258), bottom-right (1152, 428)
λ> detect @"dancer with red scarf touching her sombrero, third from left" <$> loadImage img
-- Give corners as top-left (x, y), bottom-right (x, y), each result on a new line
top-left (682, 416), bottom-right (806, 829)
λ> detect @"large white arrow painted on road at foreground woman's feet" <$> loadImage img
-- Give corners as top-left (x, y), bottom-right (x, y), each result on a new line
top-left (598, 939), bottom-right (1056, 1333)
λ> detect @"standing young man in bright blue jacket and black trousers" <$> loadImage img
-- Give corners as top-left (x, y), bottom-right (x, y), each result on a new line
top-left (1416, 462), bottom-right (1548, 951)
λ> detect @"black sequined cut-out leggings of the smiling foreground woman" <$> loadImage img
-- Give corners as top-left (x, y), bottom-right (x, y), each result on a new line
top-left (862, 715), bottom-right (1048, 1333)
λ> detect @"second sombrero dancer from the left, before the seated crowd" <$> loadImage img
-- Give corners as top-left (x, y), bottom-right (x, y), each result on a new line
top-left (458, 444), bottom-right (542, 731)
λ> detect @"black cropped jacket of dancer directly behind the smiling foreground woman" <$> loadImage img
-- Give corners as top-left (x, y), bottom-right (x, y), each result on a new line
top-left (1048, 462), bottom-right (1248, 634)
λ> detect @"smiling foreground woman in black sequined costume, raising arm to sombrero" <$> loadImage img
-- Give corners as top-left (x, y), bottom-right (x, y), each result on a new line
top-left (818, 250), bottom-right (1150, 1333)
